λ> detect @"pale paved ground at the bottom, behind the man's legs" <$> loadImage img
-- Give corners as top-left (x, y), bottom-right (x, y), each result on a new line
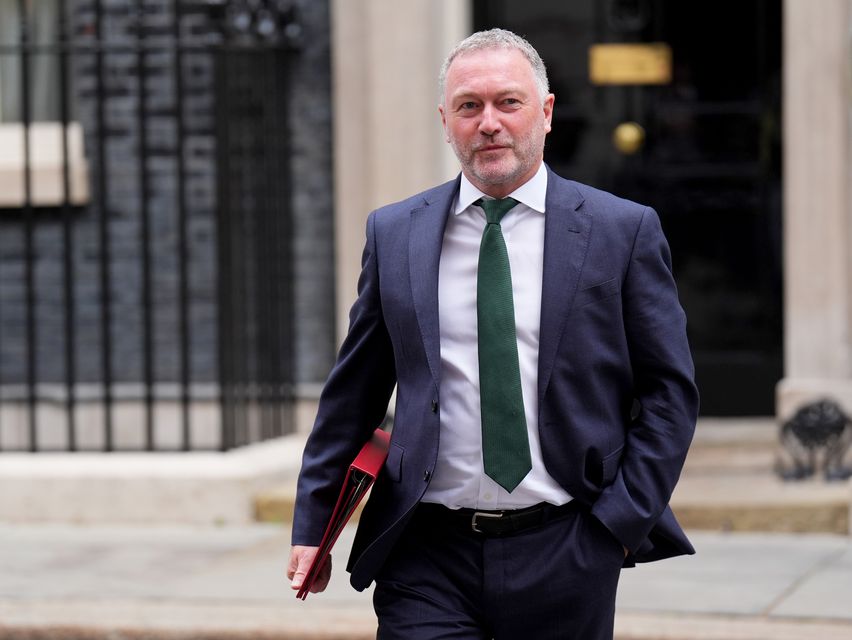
top-left (0, 525), bottom-right (852, 640)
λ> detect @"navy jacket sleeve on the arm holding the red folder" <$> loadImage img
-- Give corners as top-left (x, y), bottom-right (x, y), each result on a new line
top-left (292, 212), bottom-right (396, 546)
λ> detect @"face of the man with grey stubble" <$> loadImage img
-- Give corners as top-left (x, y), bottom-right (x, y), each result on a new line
top-left (438, 49), bottom-right (553, 198)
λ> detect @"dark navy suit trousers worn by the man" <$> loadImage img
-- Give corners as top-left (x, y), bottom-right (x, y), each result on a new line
top-left (373, 508), bottom-right (624, 640)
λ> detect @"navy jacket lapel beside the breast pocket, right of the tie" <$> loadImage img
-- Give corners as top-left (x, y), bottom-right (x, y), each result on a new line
top-left (538, 167), bottom-right (592, 402)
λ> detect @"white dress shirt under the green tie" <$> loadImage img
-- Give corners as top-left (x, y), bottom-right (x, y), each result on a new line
top-left (423, 164), bottom-right (571, 510)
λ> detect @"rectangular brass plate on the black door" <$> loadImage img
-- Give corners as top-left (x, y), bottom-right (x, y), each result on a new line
top-left (589, 42), bottom-right (672, 84)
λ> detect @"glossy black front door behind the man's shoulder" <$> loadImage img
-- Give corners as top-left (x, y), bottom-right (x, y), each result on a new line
top-left (474, 0), bottom-right (783, 416)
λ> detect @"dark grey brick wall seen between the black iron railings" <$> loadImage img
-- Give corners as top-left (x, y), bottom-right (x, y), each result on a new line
top-left (0, 0), bottom-right (334, 385)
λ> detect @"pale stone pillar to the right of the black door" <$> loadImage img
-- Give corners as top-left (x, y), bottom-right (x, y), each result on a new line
top-left (777, 0), bottom-right (852, 419)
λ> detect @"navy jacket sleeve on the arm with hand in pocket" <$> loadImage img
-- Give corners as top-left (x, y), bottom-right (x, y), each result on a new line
top-left (592, 208), bottom-right (698, 552)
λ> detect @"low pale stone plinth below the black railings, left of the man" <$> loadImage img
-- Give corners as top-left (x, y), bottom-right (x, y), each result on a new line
top-left (0, 434), bottom-right (305, 525)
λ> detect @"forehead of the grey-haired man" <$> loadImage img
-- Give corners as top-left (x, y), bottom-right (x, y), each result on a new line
top-left (446, 48), bottom-right (535, 97)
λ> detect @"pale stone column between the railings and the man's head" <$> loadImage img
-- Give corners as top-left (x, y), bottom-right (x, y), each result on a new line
top-left (332, 0), bottom-right (471, 340)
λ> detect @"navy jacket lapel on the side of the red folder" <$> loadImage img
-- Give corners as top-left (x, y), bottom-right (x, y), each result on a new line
top-left (408, 178), bottom-right (459, 385)
